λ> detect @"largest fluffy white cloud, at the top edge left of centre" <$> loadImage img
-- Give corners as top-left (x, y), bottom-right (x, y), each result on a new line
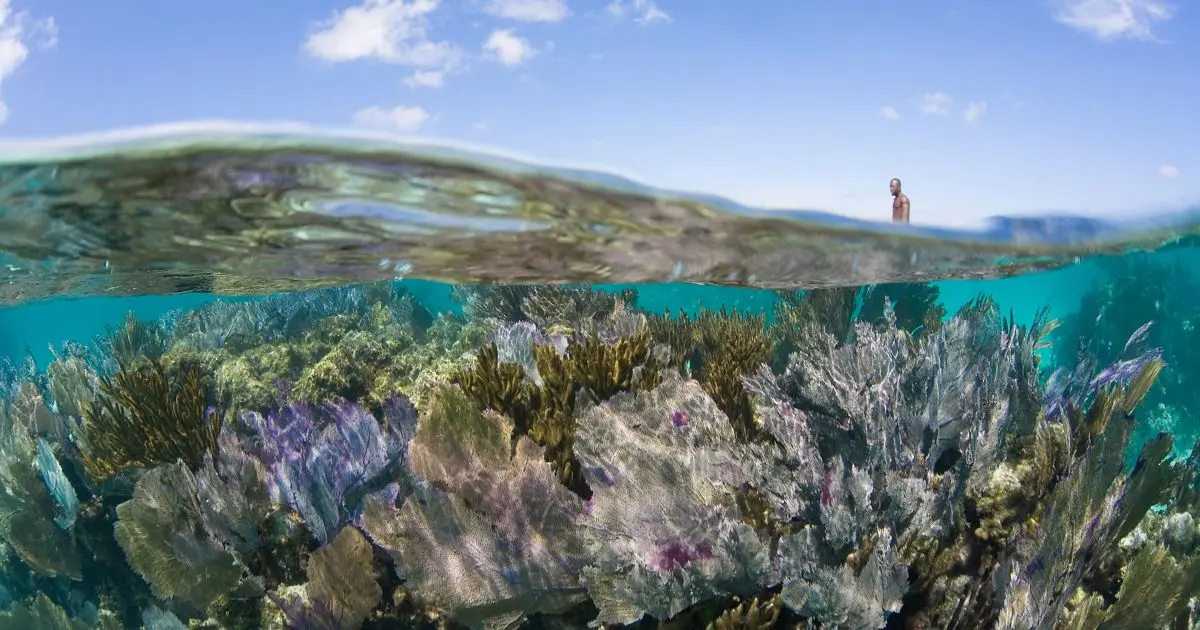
top-left (304, 0), bottom-right (463, 71)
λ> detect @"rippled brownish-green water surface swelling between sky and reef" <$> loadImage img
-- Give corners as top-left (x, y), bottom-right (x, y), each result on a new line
top-left (0, 124), bottom-right (1194, 302)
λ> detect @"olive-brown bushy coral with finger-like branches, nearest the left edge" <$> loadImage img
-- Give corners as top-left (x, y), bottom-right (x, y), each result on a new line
top-left (84, 361), bottom-right (221, 480)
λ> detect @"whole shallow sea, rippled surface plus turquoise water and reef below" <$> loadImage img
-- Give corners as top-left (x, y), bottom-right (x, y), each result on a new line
top-left (0, 128), bottom-right (1200, 630)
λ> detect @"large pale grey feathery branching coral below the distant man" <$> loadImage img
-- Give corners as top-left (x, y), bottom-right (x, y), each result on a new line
top-left (748, 297), bottom-right (1063, 628)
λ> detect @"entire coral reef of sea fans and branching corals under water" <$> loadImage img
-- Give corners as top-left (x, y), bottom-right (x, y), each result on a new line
top-left (0, 271), bottom-right (1200, 630)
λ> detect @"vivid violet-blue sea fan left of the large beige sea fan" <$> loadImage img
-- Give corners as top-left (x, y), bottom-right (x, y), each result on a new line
top-left (242, 396), bottom-right (416, 544)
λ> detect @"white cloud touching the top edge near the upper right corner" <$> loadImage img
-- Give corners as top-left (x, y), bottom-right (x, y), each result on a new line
top-left (1055, 0), bottom-right (1175, 41)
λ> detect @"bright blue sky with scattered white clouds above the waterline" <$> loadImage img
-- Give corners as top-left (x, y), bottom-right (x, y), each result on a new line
top-left (0, 0), bottom-right (1200, 226)
